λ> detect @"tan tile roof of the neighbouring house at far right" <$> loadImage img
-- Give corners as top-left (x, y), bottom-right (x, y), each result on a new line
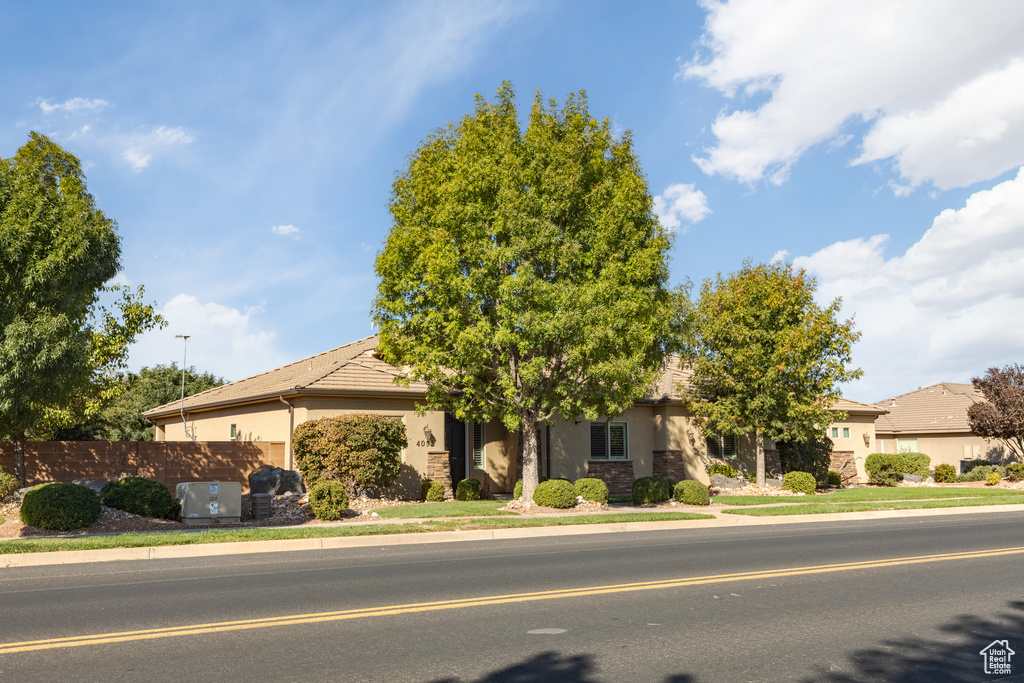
top-left (874, 382), bottom-right (984, 435)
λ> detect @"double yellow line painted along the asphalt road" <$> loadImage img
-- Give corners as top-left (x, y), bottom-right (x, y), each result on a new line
top-left (0, 547), bottom-right (1024, 654)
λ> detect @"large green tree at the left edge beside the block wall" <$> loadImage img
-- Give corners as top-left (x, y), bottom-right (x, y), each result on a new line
top-left (0, 132), bottom-right (160, 482)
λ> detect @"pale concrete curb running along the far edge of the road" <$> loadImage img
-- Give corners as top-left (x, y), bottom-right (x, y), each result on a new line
top-left (0, 505), bottom-right (1024, 567)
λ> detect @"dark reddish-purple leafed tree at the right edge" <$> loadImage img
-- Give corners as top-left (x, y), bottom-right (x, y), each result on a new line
top-left (967, 365), bottom-right (1024, 461)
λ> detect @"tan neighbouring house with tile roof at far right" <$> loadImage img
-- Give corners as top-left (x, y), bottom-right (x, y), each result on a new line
top-left (874, 382), bottom-right (1010, 471)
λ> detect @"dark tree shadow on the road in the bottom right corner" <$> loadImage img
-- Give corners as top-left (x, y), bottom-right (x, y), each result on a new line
top-left (804, 598), bottom-right (1024, 683)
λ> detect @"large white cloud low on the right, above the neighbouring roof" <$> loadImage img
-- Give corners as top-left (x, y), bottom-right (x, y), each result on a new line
top-left (794, 168), bottom-right (1024, 400)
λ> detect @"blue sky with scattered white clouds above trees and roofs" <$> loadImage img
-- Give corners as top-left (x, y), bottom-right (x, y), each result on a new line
top-left (0, 0), bottom-right (1024, 401)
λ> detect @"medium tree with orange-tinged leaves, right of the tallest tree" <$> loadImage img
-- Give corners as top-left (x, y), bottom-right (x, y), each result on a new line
top-left (682, 262), bottom-right (861, 484)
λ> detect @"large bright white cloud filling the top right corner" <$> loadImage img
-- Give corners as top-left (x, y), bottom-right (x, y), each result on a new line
top-left (681, 0), bottom-right (1024, 193)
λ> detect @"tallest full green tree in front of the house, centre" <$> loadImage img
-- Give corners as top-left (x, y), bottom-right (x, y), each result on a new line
top-left (373, 83), bottom-right (675, 500)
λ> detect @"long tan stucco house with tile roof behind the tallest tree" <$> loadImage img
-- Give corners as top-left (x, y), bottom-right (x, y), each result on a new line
top-left (143, 336), bottom-right (885, 497)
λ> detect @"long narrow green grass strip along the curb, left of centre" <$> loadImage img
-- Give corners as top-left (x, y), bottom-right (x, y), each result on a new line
top-left (0, 512), bottom-right (713, 555)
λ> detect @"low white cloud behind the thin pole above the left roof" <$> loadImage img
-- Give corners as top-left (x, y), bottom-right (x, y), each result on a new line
top-left (131, 294), bottom-right (288, 381)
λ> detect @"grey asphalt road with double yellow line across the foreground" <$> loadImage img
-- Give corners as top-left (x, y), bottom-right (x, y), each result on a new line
top-left (0, 512), bottom-right (1024, 683)
